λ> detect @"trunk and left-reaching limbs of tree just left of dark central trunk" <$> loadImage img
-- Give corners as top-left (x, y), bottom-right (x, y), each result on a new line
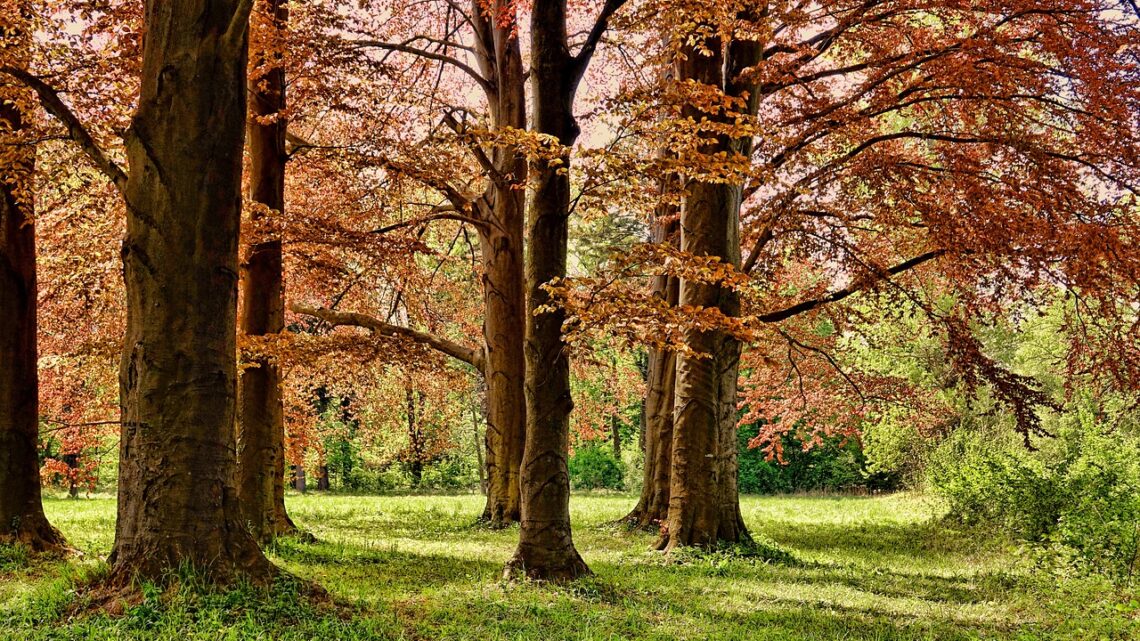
top-left (298, 0), bottom-right (527, 527)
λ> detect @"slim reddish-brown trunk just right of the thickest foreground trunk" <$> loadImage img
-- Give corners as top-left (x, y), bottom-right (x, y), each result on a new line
top-left (237, 0), bottom-right (296, 542)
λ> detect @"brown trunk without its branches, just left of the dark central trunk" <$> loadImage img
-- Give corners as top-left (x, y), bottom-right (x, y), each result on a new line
top-left (472, 0), bottom-right (527, 527)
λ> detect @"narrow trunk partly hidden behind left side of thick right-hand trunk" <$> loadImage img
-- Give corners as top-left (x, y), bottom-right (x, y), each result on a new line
top-left (624, 180), bottom-right (679, 529)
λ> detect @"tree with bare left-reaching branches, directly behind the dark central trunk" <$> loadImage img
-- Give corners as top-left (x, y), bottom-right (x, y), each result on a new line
top-left (289, 0), bottom-right (527, 526)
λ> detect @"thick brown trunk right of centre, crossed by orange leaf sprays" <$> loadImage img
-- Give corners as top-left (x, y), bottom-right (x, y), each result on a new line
top-left (658, 17), bottom-right (762, 551)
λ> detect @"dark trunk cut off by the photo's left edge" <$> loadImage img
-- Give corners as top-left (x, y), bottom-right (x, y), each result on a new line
top-left (0, 24), bottom-right (65, 552)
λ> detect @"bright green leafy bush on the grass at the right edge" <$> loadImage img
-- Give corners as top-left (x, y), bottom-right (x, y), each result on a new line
top-left (928, 406), bottom-right (1140, 584)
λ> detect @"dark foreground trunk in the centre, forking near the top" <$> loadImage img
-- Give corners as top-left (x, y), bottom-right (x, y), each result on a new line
top-left (507, 0), bottom-right (589, 581)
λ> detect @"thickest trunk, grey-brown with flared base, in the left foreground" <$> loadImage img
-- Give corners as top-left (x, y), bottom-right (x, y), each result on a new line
top-left (111, 0), bottom-right (277, 586)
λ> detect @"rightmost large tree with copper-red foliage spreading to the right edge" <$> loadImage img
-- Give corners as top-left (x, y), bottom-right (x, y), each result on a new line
top-left (547, 0), bottom-right (1140, 545)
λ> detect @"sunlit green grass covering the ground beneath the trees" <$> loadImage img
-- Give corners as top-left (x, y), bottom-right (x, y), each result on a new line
top-left (0, 494), bottom-right (1140, 641)
